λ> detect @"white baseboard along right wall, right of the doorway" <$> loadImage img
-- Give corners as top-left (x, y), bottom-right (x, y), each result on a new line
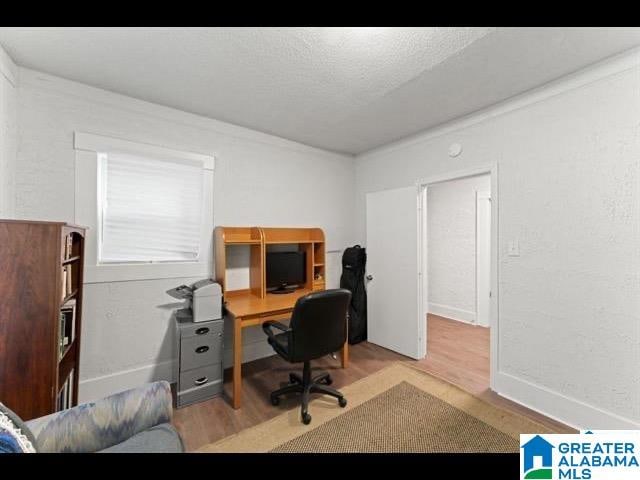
top-left (495, 372), bottom-right (640, 430)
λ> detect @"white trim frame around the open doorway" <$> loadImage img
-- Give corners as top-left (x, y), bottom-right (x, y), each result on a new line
top-left (416, 163), bottom-right (500, 390)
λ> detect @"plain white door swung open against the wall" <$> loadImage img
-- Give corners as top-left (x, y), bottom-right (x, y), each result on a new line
top-left (366, 187), bottom-right (425, 358)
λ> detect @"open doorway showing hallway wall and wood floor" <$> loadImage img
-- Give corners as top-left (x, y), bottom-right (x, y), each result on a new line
top-left (421, 171), bottom-right (497, 393)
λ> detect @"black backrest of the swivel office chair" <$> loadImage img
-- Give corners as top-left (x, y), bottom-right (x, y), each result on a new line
top-left (289, 288), bottom-right (351, 362)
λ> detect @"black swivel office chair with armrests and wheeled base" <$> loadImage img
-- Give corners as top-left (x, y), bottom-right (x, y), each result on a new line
top-left (262, 288), bottom-right (351, 424)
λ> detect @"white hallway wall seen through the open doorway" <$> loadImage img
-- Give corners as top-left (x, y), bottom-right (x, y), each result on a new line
top-left (427, 175), bottom-right (491, 322)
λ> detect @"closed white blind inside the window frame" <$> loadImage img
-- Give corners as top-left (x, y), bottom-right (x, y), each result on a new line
top-left (98, 153), bottom-right (203, 263)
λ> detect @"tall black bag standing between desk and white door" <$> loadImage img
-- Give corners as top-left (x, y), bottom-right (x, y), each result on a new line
top-left (340, 245), bottom-right (367, 345)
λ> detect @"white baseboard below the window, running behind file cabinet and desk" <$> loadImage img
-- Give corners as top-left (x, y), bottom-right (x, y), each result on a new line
top-left (78, 342), bottom-right (274, 403)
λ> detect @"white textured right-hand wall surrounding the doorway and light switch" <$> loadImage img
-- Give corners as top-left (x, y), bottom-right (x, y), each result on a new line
top-left (355, 50), bottom-right (640, 428)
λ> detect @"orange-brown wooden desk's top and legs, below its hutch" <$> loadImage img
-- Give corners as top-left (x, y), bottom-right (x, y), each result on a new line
top-left (226, 289), bottom-right (349, 408)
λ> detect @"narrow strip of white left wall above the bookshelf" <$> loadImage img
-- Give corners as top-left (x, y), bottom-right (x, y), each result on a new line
top-left (0, 46), bottom-right (17, 218)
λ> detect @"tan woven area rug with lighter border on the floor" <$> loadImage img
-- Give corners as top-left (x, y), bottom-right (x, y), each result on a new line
top-left (198, 362), bottom-right (551, 453)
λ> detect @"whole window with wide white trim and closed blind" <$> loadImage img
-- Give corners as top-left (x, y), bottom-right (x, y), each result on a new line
top-left (74, 132), bottom-right (215, 283)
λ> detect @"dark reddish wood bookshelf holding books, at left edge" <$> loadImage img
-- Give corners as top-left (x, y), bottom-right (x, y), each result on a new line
top-left (0, 220), bottom-right (85, 420)
